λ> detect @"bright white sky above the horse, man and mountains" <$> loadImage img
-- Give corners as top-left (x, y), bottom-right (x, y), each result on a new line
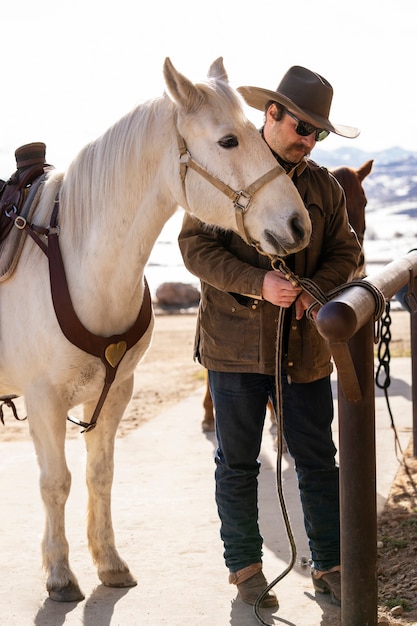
top-left (0, 0), bottom-right (417, 173)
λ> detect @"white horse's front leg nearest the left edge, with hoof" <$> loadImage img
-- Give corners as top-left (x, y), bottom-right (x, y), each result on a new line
top-left (25, 385), bottom-right (84, 602)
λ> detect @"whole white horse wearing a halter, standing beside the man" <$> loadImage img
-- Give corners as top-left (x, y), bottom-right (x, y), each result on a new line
top-left (0, 58), bottom-right (311, 601)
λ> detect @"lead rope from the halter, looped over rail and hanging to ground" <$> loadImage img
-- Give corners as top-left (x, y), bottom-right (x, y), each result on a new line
top-left (253, 257), bottom-right (385, 626)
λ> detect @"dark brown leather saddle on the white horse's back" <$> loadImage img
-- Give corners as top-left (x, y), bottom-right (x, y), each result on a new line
top-left (0, 142), bottom-right (51, 282)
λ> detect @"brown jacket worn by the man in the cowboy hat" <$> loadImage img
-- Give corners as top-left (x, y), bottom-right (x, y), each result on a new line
top-left (179, 159), bottom-right (360, 382)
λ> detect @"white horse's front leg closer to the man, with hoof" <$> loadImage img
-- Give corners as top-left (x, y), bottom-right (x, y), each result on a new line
top-left (84, 376), bottom-right (137, 587)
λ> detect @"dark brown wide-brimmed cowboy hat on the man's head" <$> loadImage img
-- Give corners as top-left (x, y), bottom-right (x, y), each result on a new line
top-left (238, 65), bottom-right (360, 138)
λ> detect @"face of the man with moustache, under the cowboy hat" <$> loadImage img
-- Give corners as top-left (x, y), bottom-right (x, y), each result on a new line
top-left (264, 104), bottom-right (316, 163)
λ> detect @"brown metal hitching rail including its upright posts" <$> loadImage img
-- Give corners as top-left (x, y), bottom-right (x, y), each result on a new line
top-left (316, 250), bottom-right (417, 626)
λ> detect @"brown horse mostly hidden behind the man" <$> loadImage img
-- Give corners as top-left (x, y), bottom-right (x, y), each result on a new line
top-left (201, 160), bottom-right (373, 432)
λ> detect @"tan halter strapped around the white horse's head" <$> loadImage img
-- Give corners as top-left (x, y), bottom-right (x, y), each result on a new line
top-left (175, 125), bottom-right (285, 247)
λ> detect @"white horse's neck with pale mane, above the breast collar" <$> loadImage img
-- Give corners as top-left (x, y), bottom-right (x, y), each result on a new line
top-left (37, 98), bottom-right (181, 332)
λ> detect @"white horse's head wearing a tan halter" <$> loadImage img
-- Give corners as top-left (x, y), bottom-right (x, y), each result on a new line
top-left (164, 58), bottom-right (311, 256)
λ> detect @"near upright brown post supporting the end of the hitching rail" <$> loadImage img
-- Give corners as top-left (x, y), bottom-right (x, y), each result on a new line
top-left (338, 321), bottom-right (378, 626)
